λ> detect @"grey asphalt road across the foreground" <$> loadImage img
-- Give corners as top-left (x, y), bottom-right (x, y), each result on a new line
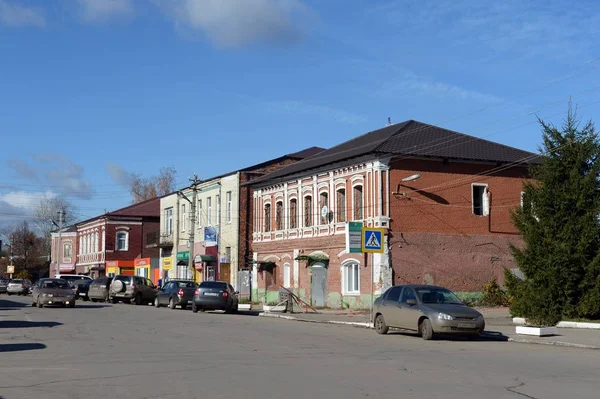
top-left (0, 295), bottom-right (600, 399)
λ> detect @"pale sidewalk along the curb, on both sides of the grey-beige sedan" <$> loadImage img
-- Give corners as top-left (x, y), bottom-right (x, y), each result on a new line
top-left (260, 308), bottom-right (600, 350)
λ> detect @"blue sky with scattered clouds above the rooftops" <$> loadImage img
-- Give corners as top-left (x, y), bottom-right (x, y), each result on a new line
top-left (0, 0), bottom-right (600, 231)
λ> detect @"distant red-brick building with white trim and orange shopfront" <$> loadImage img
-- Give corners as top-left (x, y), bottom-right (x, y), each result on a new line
top-left (50, 198), bottom-right (160, 278)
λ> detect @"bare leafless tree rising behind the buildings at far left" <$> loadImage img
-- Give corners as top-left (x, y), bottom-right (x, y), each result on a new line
top-left (35, 196), bottom-right (77, 254)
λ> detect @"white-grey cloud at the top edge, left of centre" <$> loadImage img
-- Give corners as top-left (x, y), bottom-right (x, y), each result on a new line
top-left (154, 0), bottom-right (309, 47)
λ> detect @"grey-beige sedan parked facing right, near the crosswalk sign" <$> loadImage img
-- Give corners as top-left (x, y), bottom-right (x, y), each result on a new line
top-left (374, 285), bottom-right (485, 340)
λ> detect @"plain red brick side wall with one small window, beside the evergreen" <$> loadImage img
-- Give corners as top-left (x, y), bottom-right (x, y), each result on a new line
top-left (389, 160), bottom-right (527, 291)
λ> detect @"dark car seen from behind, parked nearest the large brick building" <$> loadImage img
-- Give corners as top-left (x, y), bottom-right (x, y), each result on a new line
top-left (192, 281), bottom-right (239, 313)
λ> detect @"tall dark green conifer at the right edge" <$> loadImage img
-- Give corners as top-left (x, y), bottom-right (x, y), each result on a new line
top-left (505, 107), bottom-right (600, 325)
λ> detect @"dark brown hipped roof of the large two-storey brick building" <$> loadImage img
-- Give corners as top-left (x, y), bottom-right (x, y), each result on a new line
top-left (246, 120), bottom-right (539, 184)
